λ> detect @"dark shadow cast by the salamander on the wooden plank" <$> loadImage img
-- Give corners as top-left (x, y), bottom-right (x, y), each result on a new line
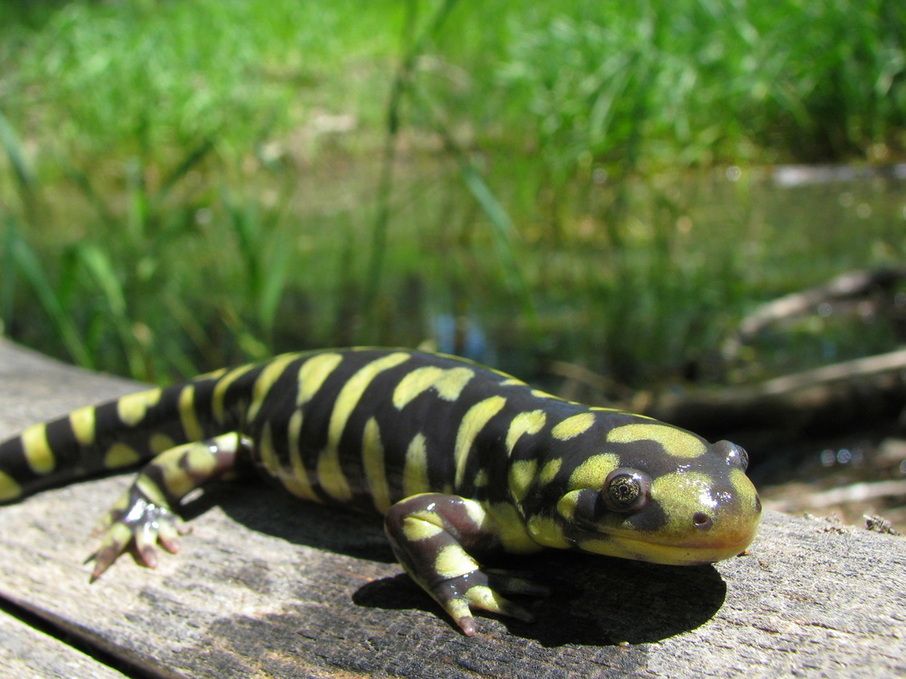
top-left (207, 483), bottom-right (726, 647)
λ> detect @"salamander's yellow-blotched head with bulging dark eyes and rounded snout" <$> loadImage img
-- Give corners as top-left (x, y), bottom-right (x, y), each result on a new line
top-left (528, 421), bottom-right (761, 565)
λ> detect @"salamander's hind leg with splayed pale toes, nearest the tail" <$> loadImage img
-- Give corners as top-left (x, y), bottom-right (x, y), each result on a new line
top-left (89, 433), bottom-right (248, 582)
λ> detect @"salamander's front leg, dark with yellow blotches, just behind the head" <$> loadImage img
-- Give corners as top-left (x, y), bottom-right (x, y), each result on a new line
top-left (384, 493), bottom-right (548, 636)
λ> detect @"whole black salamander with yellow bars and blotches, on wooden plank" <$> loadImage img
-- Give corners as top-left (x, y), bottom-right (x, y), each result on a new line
top-left (0, 349), bottom-right (761, 635)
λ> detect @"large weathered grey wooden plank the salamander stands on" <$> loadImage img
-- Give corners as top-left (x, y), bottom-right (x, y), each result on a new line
top-left (0, 343), bottom-right (906, 677)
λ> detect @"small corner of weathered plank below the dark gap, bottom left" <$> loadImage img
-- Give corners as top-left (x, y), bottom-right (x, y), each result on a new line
top-left (0, 611), bottom-right (125, 679)
